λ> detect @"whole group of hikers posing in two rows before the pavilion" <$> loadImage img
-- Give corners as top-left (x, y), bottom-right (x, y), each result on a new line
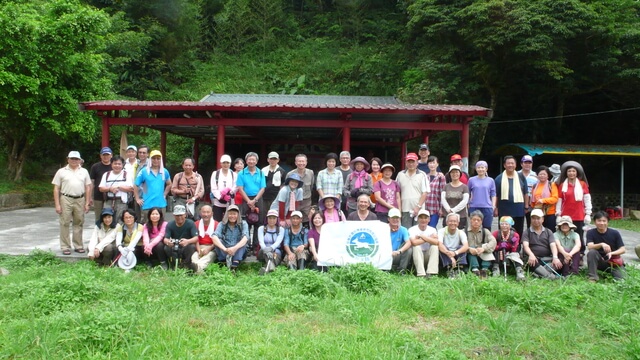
top-left (53, 144), bottom-right (625, 281)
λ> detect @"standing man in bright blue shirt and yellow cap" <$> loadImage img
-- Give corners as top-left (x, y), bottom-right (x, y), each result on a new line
top-left (133, 150), bottom-right (171, 224)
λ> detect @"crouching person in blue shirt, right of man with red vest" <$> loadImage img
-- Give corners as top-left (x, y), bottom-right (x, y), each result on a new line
top-left (213, 205), bottom-right (249, 273)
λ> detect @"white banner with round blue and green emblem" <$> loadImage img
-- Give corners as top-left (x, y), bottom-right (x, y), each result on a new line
top-left (318, 221), bottom-right (393, 270)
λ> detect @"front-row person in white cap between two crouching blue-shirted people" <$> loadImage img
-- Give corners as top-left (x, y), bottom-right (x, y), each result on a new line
top-left (258, 210), bottom-right (285, 275)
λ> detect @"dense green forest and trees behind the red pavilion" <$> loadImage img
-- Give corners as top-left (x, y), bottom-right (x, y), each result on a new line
top-left (0, 0), bottom-right (640, 186)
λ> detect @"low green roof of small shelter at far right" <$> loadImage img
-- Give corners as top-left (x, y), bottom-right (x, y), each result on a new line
top-left (494, 143), bottom-right (640, 156)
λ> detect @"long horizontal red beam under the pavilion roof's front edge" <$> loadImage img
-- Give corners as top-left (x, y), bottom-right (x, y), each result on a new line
top-left (106, 118), bottom-right (463, 131)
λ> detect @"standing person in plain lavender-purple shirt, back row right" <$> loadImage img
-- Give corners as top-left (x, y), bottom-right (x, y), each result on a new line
top-left (467, 160), bottom-right (496, 230)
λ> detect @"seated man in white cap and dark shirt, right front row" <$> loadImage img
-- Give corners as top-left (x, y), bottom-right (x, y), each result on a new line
top-left (522, 209), bottom-right (562, 280)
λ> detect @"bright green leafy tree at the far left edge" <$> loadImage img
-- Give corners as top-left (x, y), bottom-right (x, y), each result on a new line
top-left (0, 0), bottom-right (110, 181)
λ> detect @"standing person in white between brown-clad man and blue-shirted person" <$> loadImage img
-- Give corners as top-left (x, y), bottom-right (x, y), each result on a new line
top-left (211, 154), bottom-right (237, 222)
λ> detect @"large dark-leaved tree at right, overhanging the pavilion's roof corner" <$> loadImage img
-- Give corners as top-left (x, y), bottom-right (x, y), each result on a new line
top-left (404, 0), bottom-right (640, 163)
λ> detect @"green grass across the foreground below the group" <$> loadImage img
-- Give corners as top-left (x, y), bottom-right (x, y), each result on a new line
top-left (0, 251), bottom-right (640, 359)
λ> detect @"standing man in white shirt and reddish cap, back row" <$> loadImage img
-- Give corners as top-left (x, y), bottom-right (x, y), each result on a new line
top-left (396, 153), bottom-right (431, 229)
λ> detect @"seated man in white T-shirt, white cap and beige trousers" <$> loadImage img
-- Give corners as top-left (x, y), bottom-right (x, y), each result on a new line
top-left (410, 209), bottom-right (440, 279)
